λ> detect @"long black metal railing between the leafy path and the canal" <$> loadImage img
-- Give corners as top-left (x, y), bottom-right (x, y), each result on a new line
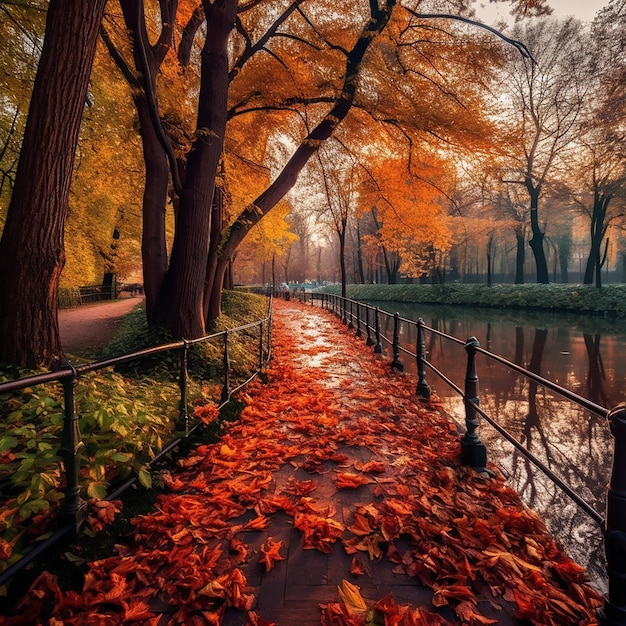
top-left (300, 293), bottom-right (626, 626)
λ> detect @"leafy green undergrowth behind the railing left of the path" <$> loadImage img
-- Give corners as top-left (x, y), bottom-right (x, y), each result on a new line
top-left (0, 292), bottom-right (268, 595)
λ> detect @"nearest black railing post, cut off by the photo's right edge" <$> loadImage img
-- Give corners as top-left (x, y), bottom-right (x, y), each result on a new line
top-left (599, 404), bottom-right (626, 626)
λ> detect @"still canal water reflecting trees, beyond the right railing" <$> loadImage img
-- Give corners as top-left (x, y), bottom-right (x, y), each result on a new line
top-left (371, 302), bottom-right (626, 592)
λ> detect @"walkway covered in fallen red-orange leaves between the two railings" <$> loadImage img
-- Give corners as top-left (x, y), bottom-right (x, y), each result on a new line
top-left (0, 301), bottom-right (601, 626)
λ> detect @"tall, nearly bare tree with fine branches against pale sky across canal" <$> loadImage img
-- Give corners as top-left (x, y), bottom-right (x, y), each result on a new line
top-left (494, 18), bottom-right (588, 283)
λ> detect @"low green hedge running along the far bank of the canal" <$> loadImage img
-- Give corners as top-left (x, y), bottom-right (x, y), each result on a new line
top-left (323, 283), bottom-right (626, 318)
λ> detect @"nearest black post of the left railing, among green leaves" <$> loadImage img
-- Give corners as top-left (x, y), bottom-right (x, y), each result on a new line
top-left (57, 363), bottom-right (87, 532)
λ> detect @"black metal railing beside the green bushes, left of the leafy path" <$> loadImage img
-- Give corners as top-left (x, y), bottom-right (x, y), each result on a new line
top-left (0, 298), bottom-right (272, 586)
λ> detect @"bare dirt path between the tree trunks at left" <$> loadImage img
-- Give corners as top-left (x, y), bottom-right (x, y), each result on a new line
top-left (59, 297), bottom-right (143, 354)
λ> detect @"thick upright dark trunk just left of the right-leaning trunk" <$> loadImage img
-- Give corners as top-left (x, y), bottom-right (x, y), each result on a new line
top-left (157, 0), bottom-right (238, 339)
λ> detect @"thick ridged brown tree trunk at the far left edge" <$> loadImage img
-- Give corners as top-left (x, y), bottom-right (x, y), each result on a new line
top-left (0, 0), bottom-right (106, 367)
